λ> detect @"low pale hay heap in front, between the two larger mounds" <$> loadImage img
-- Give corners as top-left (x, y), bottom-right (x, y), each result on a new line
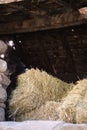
top-left (17, 101), bottom-right (60, 120)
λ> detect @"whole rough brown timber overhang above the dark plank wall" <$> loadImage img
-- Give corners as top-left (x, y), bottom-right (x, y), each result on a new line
top-left (0, 0), bottom-right (87, 34)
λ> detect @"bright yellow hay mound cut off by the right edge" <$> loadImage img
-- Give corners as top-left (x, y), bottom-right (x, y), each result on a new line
top-left (59, 79), bottom-right (87, 123)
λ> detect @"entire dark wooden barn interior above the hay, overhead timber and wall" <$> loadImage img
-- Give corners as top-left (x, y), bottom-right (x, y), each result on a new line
top-left (0, 0), bottom-right (87, 121)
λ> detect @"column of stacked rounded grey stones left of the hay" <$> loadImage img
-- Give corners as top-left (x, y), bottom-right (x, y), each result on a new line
top-left (0, 40), bottom-right (10, 121)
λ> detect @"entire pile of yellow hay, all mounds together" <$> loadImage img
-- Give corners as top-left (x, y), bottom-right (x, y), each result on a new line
top-left (9, 69), bottom-right (87, 123)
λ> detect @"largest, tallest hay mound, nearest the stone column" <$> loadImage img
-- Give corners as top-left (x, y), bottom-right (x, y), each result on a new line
top-left (10, 69), bottom-right (72, 120)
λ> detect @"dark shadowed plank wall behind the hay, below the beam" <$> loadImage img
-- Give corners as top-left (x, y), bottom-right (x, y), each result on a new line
top-left (0, 25), bottom-right (87, 82)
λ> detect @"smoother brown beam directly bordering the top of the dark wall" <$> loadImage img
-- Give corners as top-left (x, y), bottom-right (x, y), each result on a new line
top-left (0, 12), bottom-right (87, 34)
